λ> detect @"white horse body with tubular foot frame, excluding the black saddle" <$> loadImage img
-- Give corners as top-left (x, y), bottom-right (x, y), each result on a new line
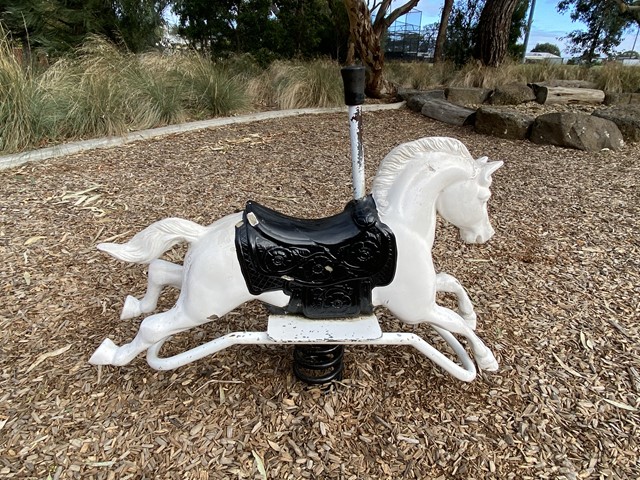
top-left (90, 137), bottom-right (502, 381)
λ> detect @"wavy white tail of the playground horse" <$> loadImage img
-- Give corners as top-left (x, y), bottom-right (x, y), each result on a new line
top-left (97, 218), bottom-right (207, 263)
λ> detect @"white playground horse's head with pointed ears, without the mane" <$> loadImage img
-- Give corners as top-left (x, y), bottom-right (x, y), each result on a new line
top-left (436, 157), bottom-right (503, 243)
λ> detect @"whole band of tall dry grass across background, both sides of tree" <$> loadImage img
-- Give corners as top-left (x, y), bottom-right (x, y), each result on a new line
top-left (0, 31), bottom-right (640, 153)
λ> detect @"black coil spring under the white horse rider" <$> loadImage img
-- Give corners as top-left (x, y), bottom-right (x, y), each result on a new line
top-left (293, 345), bottom-right (344, 385)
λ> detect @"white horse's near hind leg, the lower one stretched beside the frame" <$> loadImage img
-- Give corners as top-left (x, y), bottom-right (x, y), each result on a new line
top-left (89, 307), bottom-right (199, 365)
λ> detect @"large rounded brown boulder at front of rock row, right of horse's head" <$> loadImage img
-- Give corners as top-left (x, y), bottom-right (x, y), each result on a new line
top-left (529, 112), bottom-right (624, 151)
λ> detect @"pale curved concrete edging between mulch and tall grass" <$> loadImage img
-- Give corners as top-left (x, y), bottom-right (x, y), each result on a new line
top-left (0, 102), bottom-right (405, 170)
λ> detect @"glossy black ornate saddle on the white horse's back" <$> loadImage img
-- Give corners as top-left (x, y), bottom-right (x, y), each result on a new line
top-left (235, 195), bottom-right (397, 318)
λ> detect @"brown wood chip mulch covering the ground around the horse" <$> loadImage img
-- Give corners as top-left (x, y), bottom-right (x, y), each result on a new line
top-left (0, 110), bottom-right (640, 480)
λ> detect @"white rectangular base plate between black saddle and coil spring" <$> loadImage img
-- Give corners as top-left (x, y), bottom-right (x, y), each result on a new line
top-left (267, 315), bottom-right (382, 343)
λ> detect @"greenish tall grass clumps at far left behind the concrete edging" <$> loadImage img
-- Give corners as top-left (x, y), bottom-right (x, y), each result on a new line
top-left (0, 37), bottom-right (248, 153)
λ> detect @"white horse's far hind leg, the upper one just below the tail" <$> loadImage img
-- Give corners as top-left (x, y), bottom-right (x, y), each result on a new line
top-left (120, 259), bottom-right (183, 320)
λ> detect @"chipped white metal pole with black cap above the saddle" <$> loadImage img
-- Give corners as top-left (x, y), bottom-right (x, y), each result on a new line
top-left (341, 66), bottom-right (365, 200)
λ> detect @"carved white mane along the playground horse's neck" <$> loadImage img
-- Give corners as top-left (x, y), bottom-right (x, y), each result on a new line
top-left (372, 137), bottom-right (474, 209)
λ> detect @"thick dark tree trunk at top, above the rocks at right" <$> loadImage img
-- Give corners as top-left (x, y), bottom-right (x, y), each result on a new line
top-left (474, 0), bottom-right (518, 67)
